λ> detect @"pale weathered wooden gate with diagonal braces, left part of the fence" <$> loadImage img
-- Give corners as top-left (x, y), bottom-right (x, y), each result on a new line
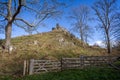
top-left (29, 59), bottom-right (61, 74)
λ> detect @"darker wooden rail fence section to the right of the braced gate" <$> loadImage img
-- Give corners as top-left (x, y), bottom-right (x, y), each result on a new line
top-left (62, 56), bottom-right (117, 70)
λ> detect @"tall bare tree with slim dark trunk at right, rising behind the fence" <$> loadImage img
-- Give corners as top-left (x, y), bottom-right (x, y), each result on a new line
top-left (93, 0), bottom-right (118, 54)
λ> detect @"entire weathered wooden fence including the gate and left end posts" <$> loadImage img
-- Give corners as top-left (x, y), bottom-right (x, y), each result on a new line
top-left (23, 56), bottom-right (118, 75)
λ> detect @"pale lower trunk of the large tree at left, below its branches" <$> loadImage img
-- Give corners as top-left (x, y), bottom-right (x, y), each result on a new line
top-left (5, 23), bottom-right (12, 52)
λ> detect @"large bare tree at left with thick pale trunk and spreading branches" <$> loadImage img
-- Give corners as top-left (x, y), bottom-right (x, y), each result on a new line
top-left (0, 0), bottom-right (65, 50)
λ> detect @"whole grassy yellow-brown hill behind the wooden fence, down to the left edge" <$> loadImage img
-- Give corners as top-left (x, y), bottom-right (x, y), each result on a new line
top-left (0, 27), bottom-right (106, 74)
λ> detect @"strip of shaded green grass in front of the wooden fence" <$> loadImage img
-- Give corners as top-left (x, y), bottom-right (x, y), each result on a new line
top-left (0, 68), bottom-right (120, 80)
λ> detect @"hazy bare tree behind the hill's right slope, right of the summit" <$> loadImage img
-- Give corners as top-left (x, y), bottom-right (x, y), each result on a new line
top-left (70, 5), bottom-right (92, 43)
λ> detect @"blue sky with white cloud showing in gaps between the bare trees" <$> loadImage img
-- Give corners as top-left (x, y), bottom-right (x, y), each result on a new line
top-left (0, 0), bottom-right (118, 44)
